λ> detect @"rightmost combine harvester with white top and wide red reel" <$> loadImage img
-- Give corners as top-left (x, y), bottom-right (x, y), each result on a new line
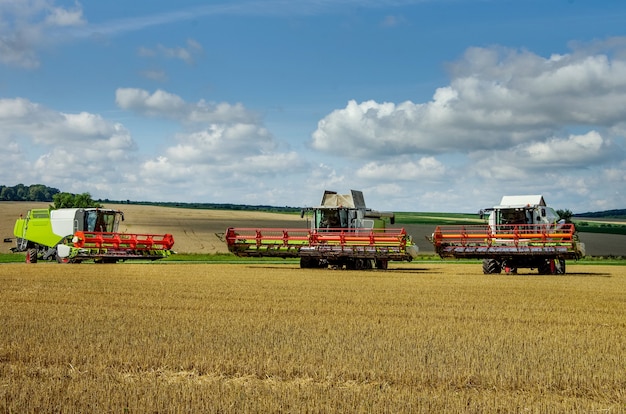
top-left (430, 195), bottom-right (585, 274)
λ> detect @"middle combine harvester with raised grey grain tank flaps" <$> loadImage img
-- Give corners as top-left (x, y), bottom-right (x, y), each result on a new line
top-left (225, 190), bottom-right (418, 269)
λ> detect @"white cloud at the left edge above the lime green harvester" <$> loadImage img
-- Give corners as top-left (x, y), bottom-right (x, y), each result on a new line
top-left (0, 98), bottom-right (137, 192)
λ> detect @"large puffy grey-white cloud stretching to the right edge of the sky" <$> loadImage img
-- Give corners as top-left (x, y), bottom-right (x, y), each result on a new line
top-left (311, 48), bottom-right (626, 157)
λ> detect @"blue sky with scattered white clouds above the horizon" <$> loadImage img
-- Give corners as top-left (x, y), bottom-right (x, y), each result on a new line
top-left (0, 0), bottom-right (626, 213)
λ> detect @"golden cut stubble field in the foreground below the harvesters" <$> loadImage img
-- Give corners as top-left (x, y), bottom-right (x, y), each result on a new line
top-left (0, 263), bottom-right (626, 413)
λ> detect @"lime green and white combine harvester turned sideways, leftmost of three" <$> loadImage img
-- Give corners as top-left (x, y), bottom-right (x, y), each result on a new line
top-left (11, 208), bottom-right (174, 263)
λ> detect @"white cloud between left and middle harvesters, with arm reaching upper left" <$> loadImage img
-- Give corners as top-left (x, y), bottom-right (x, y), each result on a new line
top-left (117, 89), bottom-right (308, 203)
